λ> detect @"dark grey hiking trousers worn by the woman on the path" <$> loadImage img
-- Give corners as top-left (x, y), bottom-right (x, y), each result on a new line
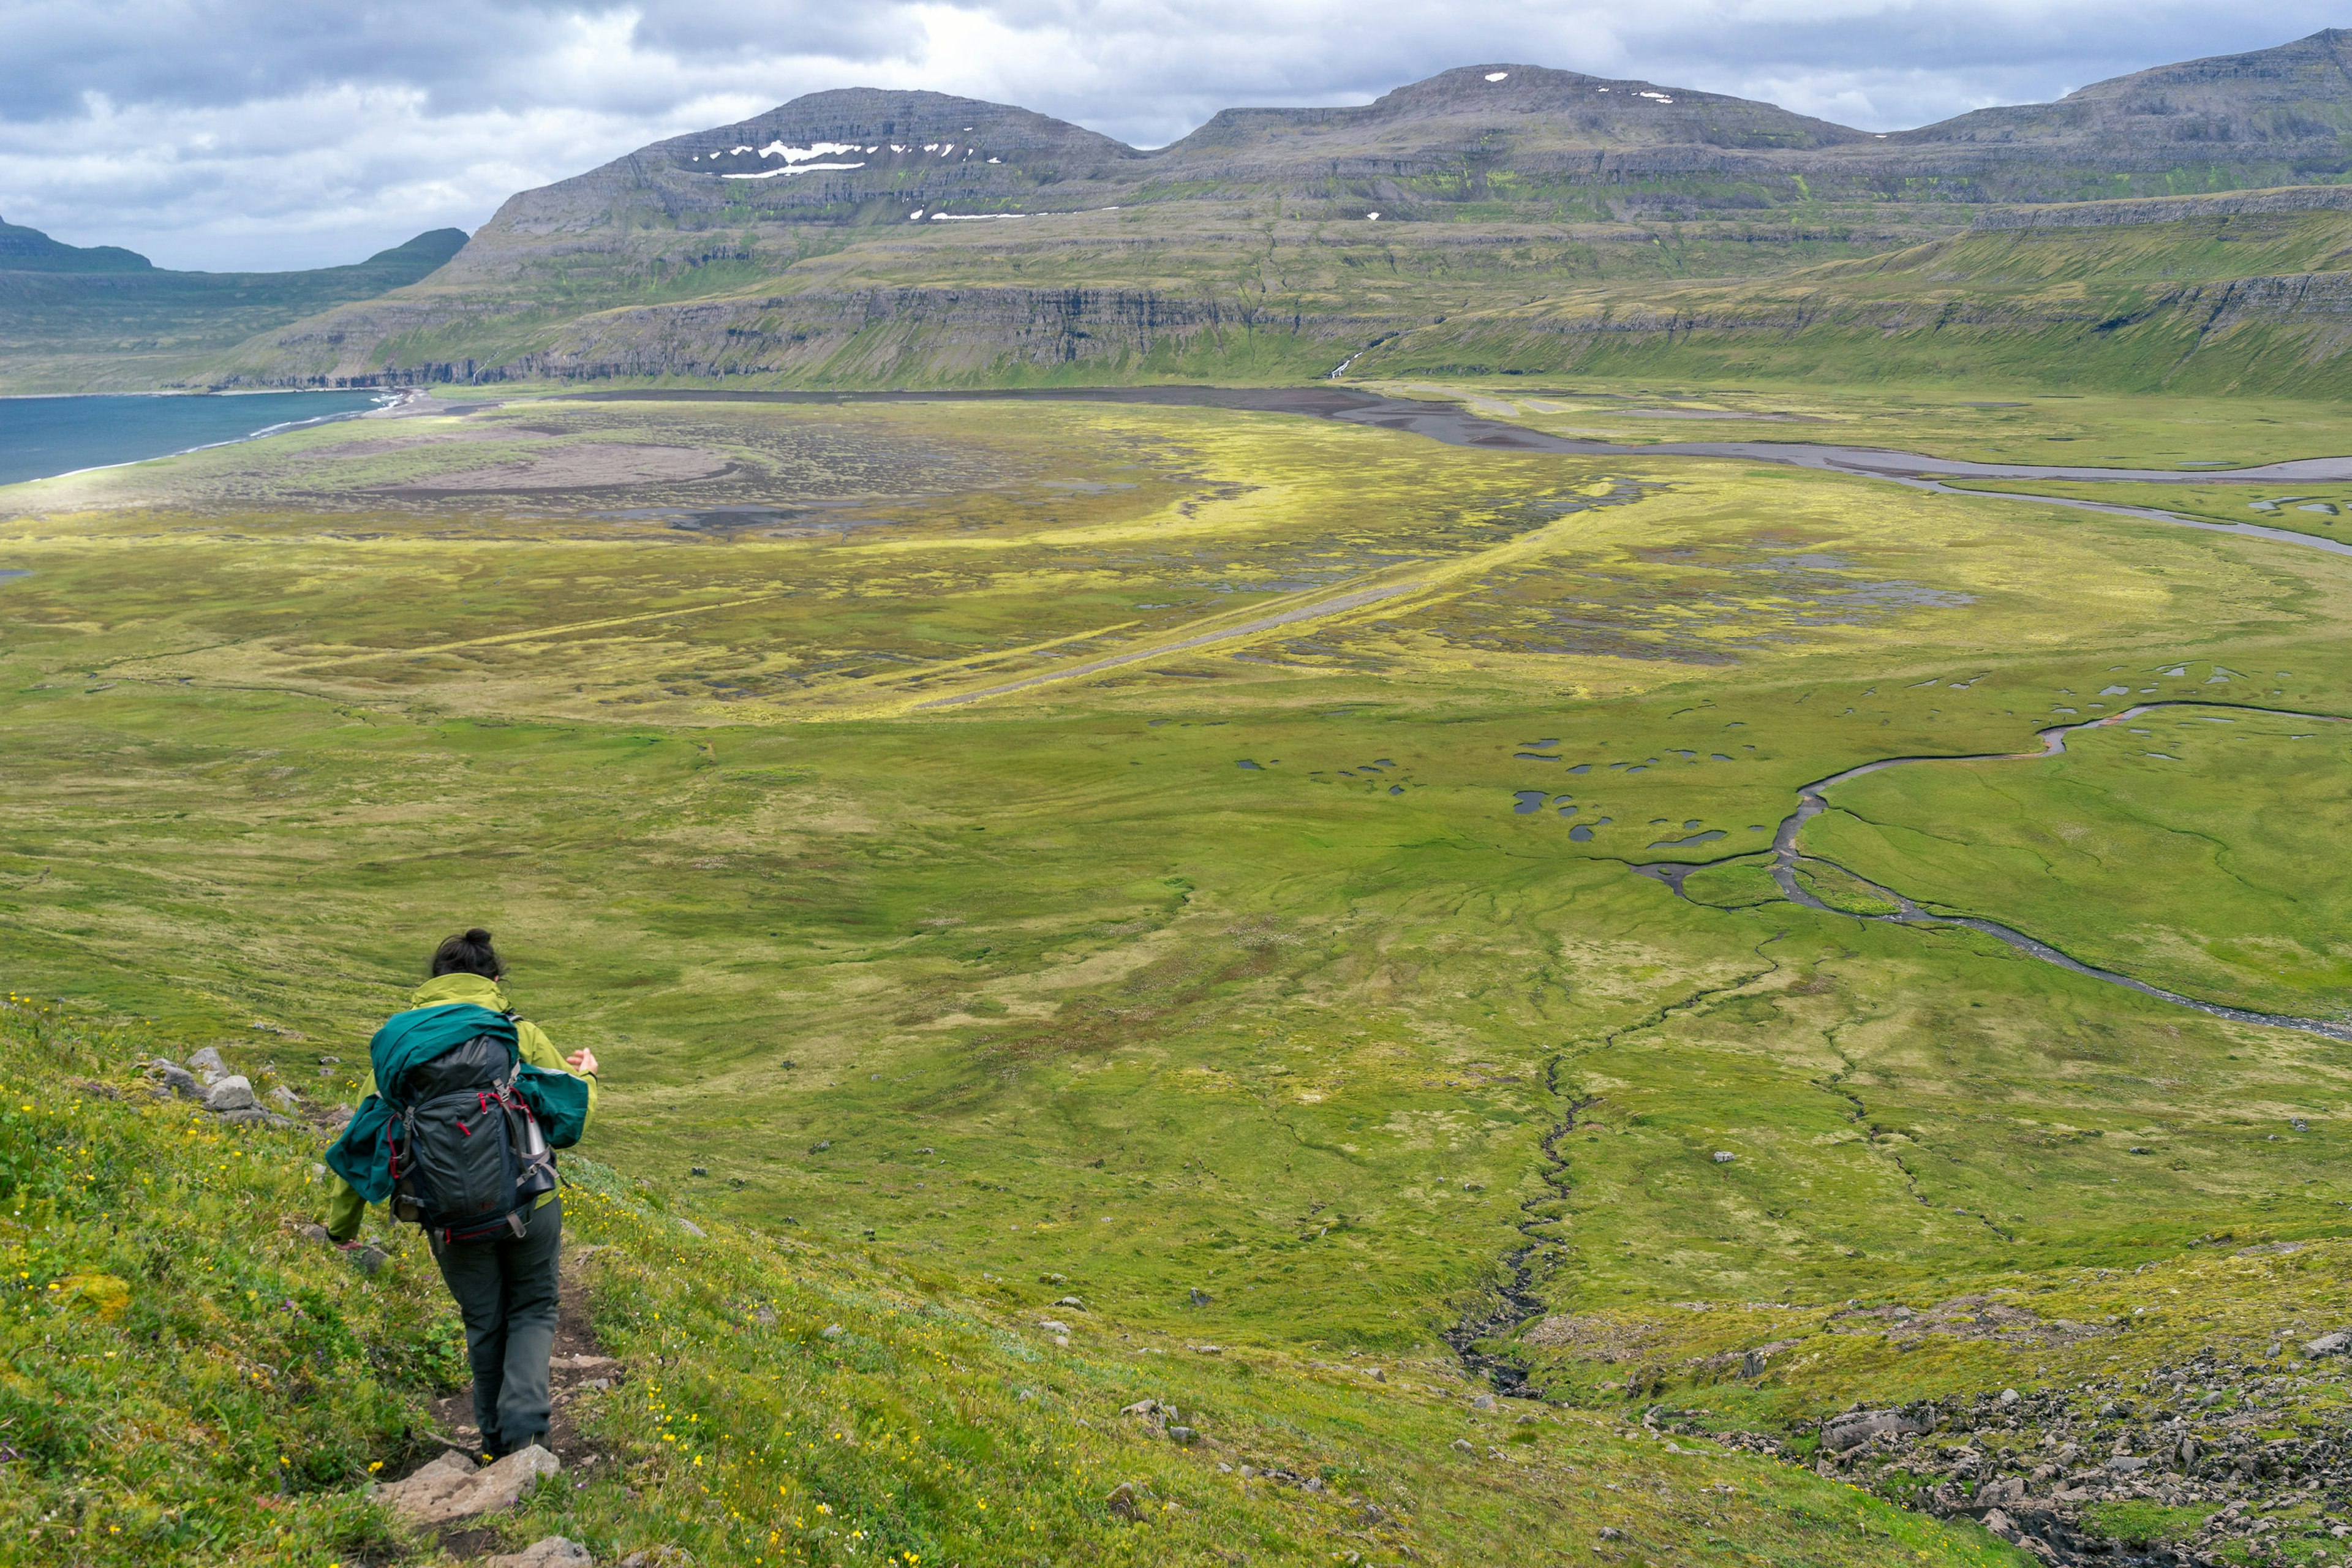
top-left (433, 1197), bottom-right (565, 1455)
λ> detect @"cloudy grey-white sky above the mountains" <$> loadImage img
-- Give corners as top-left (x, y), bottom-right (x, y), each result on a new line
top-left (0, 0), bottom-right (2352, 270)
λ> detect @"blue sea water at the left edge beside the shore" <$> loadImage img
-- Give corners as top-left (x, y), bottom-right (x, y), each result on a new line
top-left (0, 393), bottom-right (383, 484)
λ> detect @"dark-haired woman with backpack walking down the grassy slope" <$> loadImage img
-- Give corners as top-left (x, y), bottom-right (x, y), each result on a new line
top-left (327, 929), bottom-right (597, 1460)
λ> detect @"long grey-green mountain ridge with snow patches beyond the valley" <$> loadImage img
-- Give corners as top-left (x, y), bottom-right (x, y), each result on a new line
top-left (0, 31), bottom-right (2352, 385)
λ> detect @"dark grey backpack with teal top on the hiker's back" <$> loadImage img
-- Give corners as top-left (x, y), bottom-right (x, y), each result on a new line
top-left (386, 1035), bottom-right (555, 1246)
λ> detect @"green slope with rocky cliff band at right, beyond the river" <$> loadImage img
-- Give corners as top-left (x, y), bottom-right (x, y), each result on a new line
top-left (1355, 191), bottom-right (2352, 398)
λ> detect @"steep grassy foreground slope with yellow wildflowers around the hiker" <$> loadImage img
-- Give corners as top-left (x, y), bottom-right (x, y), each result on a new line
top-left (0, 995), bottom-right (2011, 1566)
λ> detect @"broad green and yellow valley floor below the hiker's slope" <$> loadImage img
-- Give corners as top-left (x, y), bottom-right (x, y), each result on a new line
top-left (13, 385), bottom-right (2352, 1563)
